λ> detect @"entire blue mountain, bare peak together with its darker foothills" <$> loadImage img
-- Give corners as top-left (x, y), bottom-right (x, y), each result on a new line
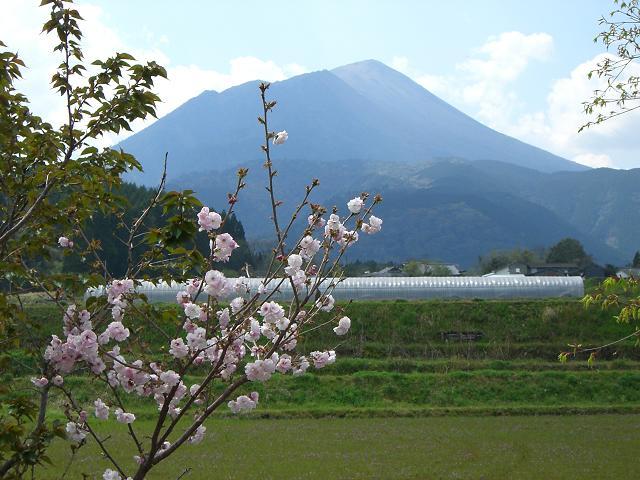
top-left (120, 61), bottom-right (640, 266)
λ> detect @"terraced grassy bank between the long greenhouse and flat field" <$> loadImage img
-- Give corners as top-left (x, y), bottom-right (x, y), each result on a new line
top-left (5, 300), bottom-right (640, 417)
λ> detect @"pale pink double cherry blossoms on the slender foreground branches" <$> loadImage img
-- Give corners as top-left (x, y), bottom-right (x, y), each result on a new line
top-left (47, 192), bottom-right (382, 478)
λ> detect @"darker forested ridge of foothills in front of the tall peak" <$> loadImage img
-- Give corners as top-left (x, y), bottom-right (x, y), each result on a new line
top-left (169, 159), bottom-right (640, 267)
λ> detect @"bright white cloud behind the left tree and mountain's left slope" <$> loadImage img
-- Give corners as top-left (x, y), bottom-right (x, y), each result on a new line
top-left (0, 0), bottom-right (308, 145)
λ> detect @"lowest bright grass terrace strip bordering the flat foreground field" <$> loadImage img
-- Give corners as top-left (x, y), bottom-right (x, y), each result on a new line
top-left (12, 370), bottom-right (640, 414)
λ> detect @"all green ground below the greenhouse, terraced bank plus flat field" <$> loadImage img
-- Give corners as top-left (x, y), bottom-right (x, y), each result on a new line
top-left (6, 300), bottom-right (640, 480)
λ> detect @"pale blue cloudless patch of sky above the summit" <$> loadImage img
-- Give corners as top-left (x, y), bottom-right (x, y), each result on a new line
top-left (81, 0), bottom-right (611, 107)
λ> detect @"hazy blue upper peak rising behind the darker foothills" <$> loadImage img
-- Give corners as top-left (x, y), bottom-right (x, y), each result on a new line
top-left (120, 60), bottom-right (586, 185)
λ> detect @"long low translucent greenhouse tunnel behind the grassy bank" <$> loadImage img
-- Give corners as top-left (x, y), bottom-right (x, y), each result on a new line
top-left (88, 275), bottom-right (584, 302)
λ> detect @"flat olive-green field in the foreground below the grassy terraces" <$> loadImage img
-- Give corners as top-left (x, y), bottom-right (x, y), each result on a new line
top-left (36, 415), bottom-right (640, 480)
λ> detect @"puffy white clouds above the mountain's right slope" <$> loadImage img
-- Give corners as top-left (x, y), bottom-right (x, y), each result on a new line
top-left (404, 32), bottom-right (640, 168)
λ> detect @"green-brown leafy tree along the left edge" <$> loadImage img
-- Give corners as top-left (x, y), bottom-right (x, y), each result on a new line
top-left (0, 0), bottom-right (166, 472)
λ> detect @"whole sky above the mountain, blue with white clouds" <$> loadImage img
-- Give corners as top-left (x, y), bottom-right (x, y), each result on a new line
top-left (0, 0), bottom-right (640, 168)
